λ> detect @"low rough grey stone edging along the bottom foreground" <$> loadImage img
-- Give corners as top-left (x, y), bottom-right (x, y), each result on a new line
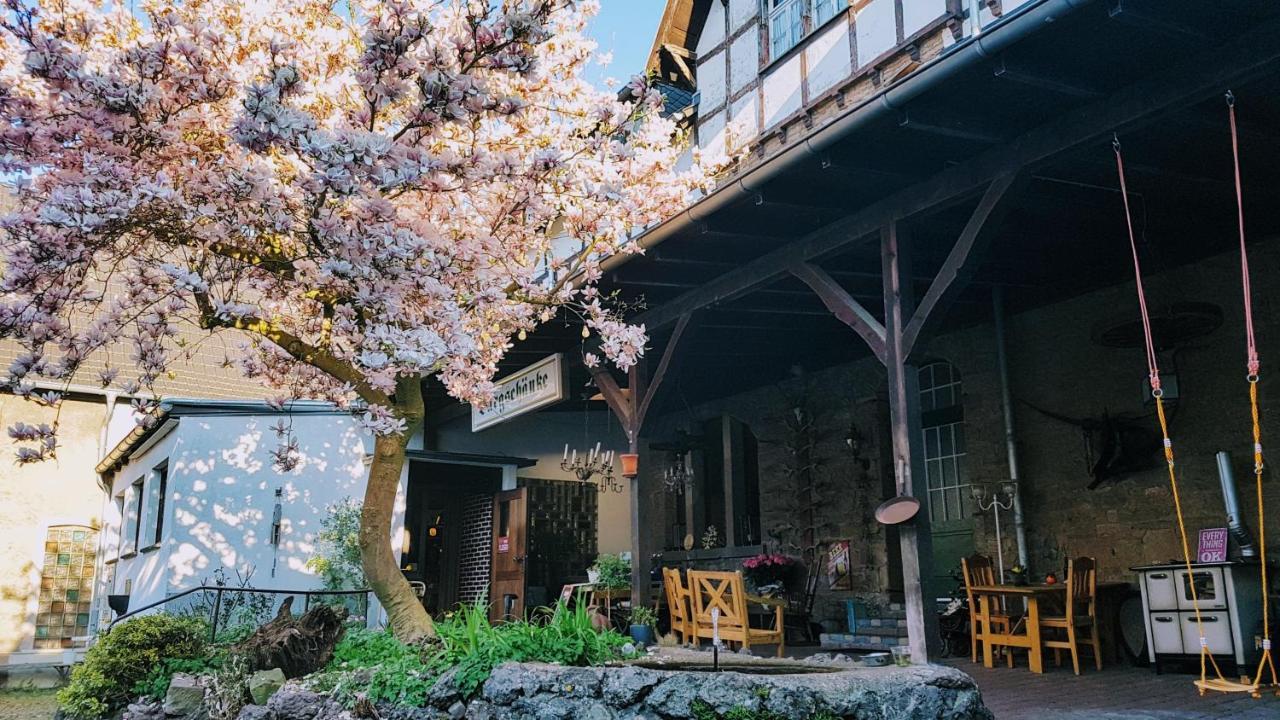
top-left (239, 664), bottom-right (991, 720)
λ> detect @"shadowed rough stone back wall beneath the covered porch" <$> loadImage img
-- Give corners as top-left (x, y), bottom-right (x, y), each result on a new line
top-left (649, 241), bottom-right (1280, 619)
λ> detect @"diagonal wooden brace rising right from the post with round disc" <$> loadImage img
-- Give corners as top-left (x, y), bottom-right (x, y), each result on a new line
top-left (902, 173), bottom-right (1027, 356)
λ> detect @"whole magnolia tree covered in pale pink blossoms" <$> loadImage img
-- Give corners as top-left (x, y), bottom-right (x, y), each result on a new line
top-left (0, 0), bottom-right (707, 639)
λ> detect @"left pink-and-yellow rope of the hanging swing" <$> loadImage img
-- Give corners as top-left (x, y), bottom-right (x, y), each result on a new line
top-left (1111, 137), bottom-right (1256, 694)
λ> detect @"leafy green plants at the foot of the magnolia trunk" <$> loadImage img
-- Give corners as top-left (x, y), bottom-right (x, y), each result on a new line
top-left (320, 597), bottom-right (627, 706)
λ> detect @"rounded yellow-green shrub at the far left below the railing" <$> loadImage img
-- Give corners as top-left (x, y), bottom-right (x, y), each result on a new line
top-left (58, 615), bottom-right (209, 720)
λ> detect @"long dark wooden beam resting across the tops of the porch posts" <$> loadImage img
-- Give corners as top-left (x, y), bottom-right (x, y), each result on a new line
top-left (635, 22), bottom-right (1280, 329)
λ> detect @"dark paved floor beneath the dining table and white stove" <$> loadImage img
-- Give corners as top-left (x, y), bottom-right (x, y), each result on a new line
top-left (946, 659), bottom-right (1280, 720)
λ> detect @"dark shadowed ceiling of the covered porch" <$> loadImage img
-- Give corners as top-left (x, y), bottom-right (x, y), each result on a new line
top-left (435, 0), bottom-right (1280, 407)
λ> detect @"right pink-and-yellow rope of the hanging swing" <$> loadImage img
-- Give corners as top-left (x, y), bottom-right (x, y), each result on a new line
top-left (1226, 91), bottom-right (1280, 697)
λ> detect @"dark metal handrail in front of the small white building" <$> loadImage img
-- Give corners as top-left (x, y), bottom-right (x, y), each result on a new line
top-left (106, 585), bottom-right (372, 641)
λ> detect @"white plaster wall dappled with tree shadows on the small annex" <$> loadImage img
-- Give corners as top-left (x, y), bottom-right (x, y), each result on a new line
top-left (109, 415), bottom-right (373, 609)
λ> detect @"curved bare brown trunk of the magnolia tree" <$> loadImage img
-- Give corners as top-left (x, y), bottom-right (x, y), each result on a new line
top-left (360, 378), bottom-right (435, 642)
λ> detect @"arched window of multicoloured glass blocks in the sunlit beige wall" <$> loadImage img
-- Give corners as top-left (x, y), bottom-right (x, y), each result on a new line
top-left (35, 525), bottom-right (97, 650)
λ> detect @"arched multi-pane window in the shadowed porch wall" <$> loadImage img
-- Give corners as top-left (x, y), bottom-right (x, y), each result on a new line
top-left (920, 360), bottom-right (972, 524)
